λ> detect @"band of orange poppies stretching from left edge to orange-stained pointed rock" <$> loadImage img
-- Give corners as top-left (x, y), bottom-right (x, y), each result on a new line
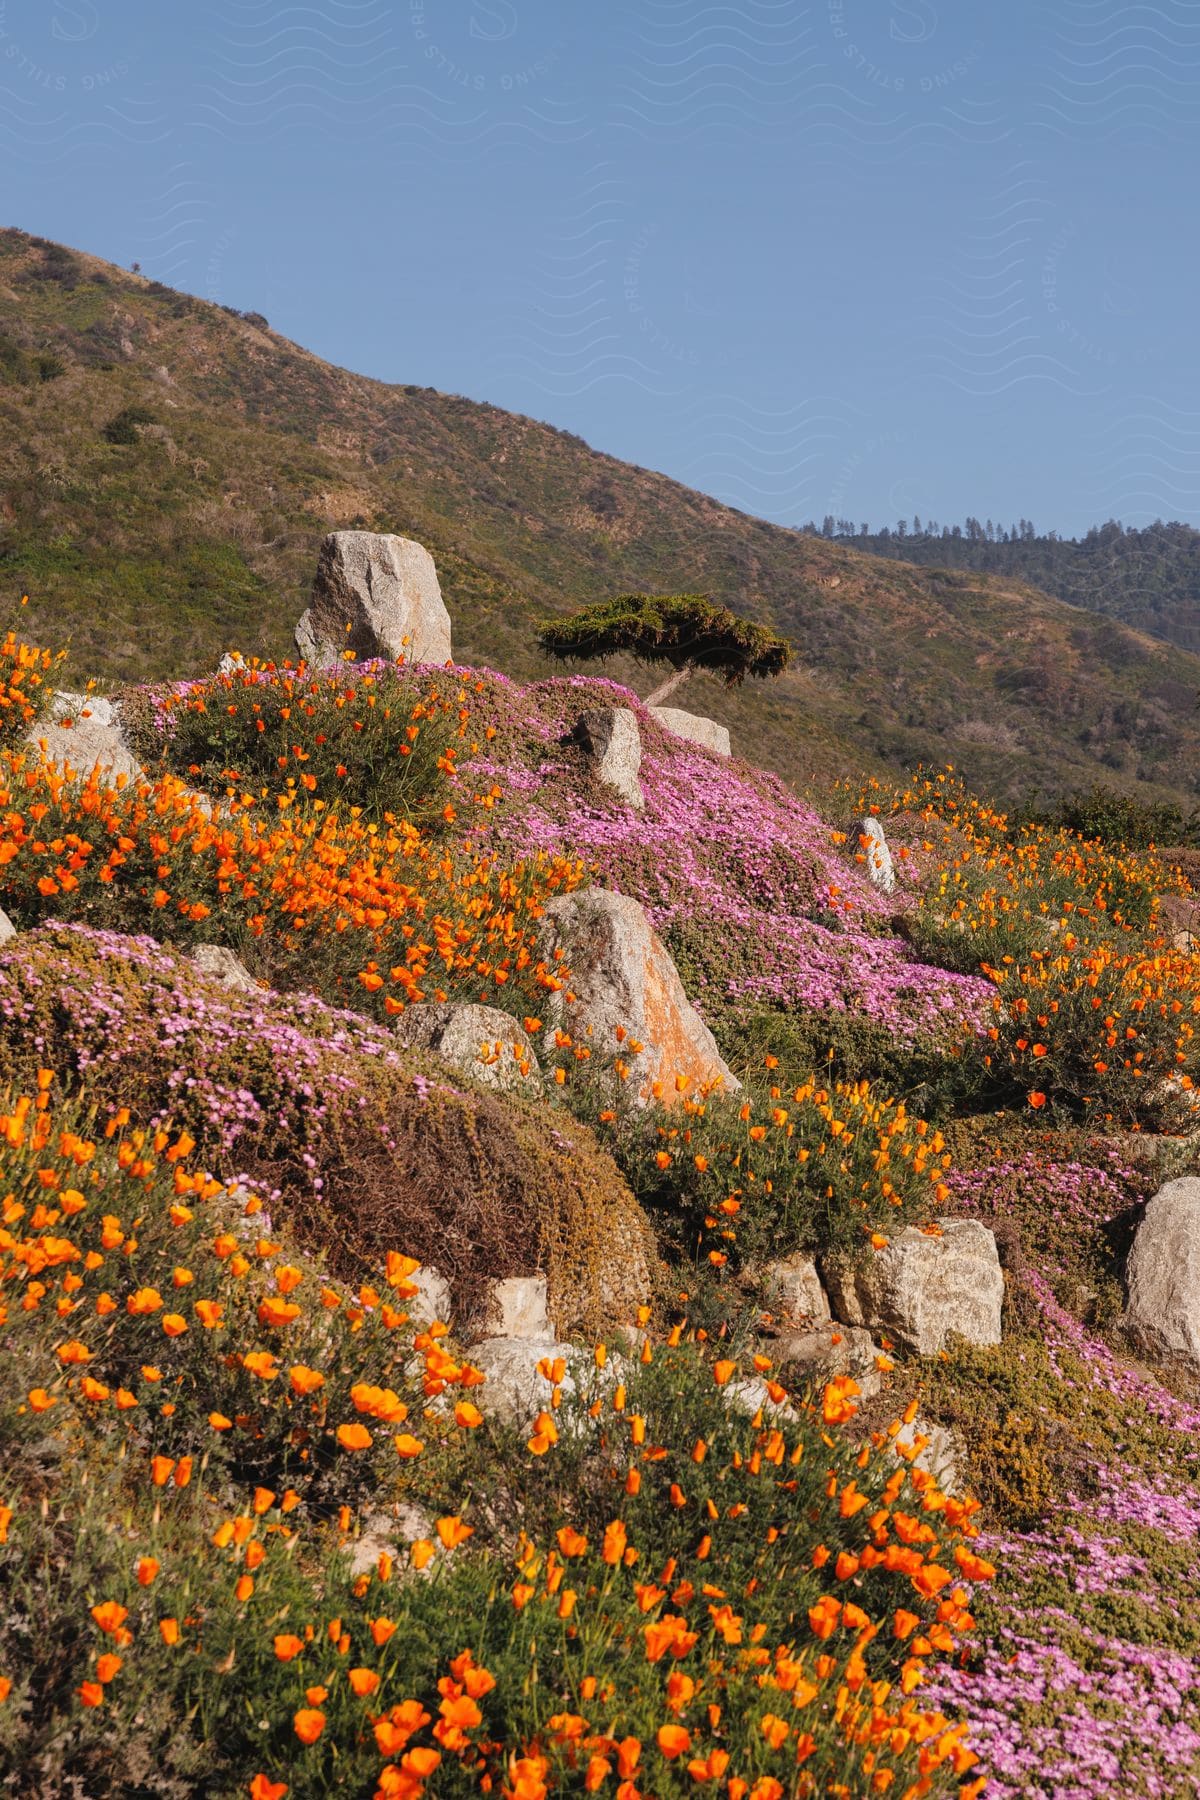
top-left (0, 751), bottom-right (585, 1013)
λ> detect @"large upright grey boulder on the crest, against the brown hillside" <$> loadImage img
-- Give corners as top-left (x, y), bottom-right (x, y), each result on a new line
top-left (295, 531), bottom-right (450, 668)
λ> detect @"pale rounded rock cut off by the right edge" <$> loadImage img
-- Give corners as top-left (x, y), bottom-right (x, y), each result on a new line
top-left (1124, 1175), bottom-right (1200, 1368)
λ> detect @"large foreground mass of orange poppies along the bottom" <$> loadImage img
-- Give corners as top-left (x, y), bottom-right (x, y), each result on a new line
top-left (0, 1071), bottom-right (993, 1800)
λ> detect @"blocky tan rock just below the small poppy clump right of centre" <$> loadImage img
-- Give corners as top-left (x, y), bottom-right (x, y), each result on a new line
top-left (822, 1219), bottom-right (1004, 1355)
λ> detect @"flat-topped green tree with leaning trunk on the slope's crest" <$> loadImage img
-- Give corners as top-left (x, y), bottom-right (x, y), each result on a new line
top-left (538, 594), bottom-right (792, 706)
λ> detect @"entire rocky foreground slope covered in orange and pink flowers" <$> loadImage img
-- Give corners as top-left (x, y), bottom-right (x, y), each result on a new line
top-left (0, 615), bottom-right (1200, 1800)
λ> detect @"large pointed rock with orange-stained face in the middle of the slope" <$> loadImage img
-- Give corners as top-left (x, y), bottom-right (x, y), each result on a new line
top-left (540, 887), bottom-right (739, 1103)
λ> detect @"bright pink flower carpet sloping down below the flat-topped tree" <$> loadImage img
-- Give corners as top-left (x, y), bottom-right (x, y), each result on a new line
top-left (460, 671), bottom-right (993, 1039)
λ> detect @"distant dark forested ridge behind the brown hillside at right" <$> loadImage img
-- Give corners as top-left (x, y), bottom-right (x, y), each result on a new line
top-left (802, 515), bottom-right (1200, 650)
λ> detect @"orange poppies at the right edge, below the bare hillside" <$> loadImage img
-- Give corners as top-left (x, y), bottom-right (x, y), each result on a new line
top-left (860, 774), bottom-right (1200, 1123)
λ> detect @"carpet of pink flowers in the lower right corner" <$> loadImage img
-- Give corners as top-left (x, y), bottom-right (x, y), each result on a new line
top-left (937, 1154), bottom-right (1200, 1800)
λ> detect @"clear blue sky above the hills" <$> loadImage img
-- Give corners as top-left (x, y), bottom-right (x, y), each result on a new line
top-left (0, 0), bottom-right (1200, 533)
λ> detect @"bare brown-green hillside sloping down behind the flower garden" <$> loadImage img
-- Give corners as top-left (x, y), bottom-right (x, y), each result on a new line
top-left (0, 230), bottom-right (1200, 806)
